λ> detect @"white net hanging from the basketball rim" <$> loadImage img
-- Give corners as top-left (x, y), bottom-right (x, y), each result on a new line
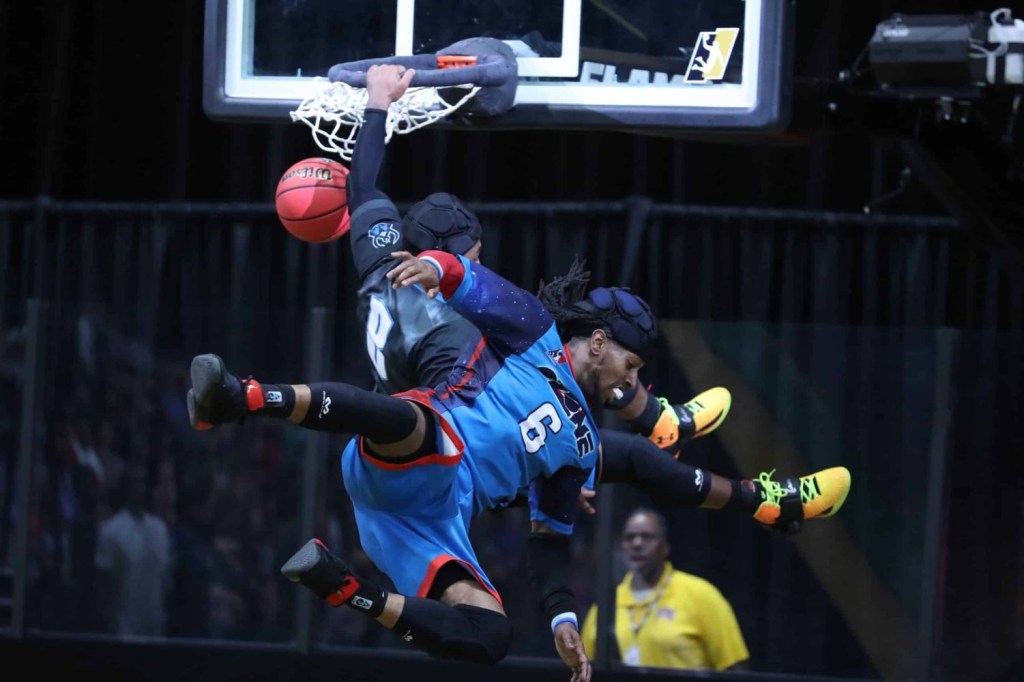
top-left (291, 78), bottom-right (480, 161)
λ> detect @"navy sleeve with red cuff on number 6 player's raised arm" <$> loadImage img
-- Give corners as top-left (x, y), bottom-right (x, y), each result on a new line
top-left (420, 251), bottom-right (555, 355)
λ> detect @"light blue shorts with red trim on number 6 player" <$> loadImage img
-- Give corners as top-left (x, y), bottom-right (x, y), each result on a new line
top-left (341, 403), bottom-right (501, 603)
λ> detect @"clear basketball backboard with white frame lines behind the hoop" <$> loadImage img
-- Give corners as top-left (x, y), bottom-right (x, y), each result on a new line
top-left (203, 0), bottom-right (793, 130)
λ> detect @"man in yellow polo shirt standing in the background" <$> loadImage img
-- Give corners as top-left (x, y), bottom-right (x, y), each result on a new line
top-left (582, 508), bottom-right (750, 671)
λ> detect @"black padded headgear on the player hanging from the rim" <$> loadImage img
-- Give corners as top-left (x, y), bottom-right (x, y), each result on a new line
top-left (401, 191), bottom-right (483, 255)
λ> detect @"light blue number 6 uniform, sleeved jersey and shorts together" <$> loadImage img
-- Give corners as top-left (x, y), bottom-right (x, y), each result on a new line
top-left (342, 252), bottom-right (599, 597)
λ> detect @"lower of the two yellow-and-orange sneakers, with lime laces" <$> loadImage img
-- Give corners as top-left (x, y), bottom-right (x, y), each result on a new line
top-left (754, 467), bottom-right (850, 529)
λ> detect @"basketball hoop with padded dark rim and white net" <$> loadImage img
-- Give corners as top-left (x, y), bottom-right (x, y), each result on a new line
top-left (291, 38), bottom-right (518, 161)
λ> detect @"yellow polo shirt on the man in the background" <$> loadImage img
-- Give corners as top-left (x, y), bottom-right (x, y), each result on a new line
top-left (581, 562), bottom-right (750, 670)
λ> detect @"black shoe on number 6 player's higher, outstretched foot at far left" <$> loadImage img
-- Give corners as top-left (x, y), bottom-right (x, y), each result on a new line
top-left (186, 353), bottom-right (248, 431)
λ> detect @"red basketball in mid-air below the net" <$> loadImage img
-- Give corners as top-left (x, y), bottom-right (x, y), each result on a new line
top-left (274, 158), bottom-right (349, 244)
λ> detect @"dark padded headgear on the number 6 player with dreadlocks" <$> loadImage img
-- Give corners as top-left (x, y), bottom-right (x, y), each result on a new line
top-left (571, 287), bottom-right (657, 357)
